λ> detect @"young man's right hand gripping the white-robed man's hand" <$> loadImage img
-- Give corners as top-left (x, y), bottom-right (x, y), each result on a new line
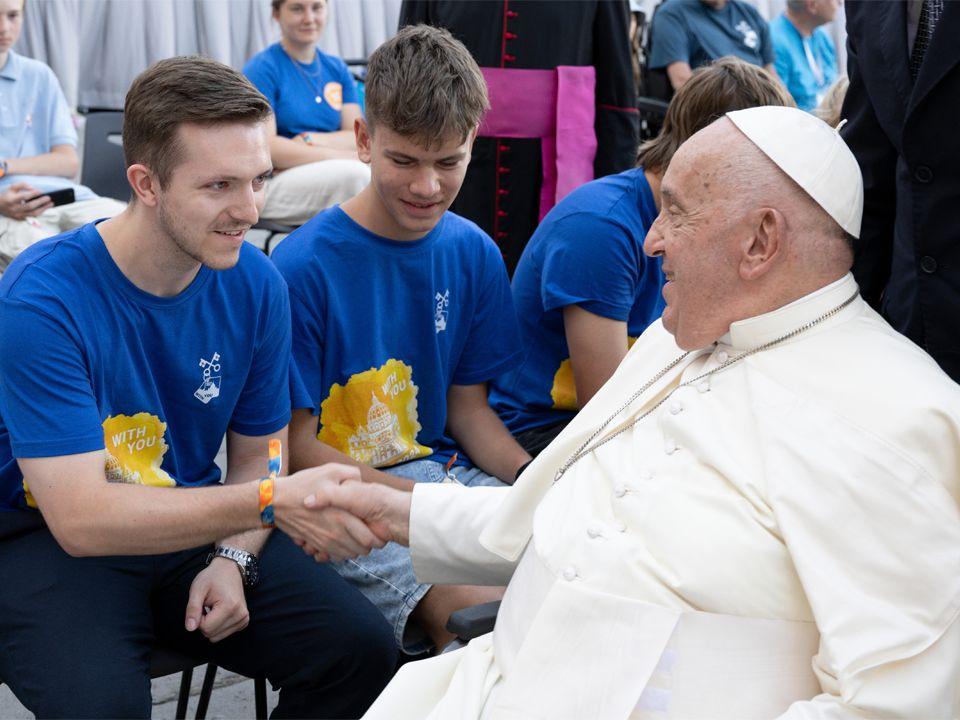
top-left (273, 463), bottom-right (385, 561)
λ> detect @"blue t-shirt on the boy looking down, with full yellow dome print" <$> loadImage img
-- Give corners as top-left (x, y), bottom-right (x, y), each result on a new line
top-left (273, 207), bottom-right (520, 467)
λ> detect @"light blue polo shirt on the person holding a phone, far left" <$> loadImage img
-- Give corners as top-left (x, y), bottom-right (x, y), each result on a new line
top-left (0, 50), bottom-right (97, 200)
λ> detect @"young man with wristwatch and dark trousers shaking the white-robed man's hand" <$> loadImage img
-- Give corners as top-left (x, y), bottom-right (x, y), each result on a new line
top-left (0, 57), bottom-right (396, 718)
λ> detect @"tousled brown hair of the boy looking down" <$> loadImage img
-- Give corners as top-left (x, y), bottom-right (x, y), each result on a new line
top-left (365, 25), bottom-right (490, 145)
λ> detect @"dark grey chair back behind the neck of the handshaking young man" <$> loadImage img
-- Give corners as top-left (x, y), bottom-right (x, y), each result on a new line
top-left (80, 110), bottom-right (130, 202)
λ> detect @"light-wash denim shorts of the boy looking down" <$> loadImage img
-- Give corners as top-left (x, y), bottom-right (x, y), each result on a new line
top-left (333, 459), bottom-right (506, 655)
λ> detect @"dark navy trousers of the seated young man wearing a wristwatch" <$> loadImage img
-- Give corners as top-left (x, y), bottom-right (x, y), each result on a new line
top-left (0, 528), bottom-right (397, 718)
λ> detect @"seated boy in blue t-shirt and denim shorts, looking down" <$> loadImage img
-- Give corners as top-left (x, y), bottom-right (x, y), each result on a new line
top-left (273, 25), bottom-right (530, 652)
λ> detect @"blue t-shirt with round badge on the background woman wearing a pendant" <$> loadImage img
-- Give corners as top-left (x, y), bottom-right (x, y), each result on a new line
top-left (243, 43), bottom-right (360, 137)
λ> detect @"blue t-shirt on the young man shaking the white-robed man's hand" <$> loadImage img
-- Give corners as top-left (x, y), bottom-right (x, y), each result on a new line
top-left (0, 225), bottom-right (290, 511)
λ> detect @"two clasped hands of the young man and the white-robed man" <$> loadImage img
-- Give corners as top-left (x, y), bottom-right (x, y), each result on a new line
top-left (273, 463), bottom-right (412, 562)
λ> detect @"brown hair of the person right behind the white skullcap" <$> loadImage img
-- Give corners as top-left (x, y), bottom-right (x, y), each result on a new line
top-left (637, 56), bottom-right (796, 173)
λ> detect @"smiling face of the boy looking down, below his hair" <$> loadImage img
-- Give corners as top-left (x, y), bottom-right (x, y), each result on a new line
top-left (357, 120), bottom-right (476, 240)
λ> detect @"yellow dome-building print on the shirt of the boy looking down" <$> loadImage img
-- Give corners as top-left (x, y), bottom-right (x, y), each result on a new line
top-left (317, 358), bottom-right (432, 467)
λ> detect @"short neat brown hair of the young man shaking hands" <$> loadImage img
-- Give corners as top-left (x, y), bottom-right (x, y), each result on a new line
top-left (123, 55), bottom-right (273, 186)
